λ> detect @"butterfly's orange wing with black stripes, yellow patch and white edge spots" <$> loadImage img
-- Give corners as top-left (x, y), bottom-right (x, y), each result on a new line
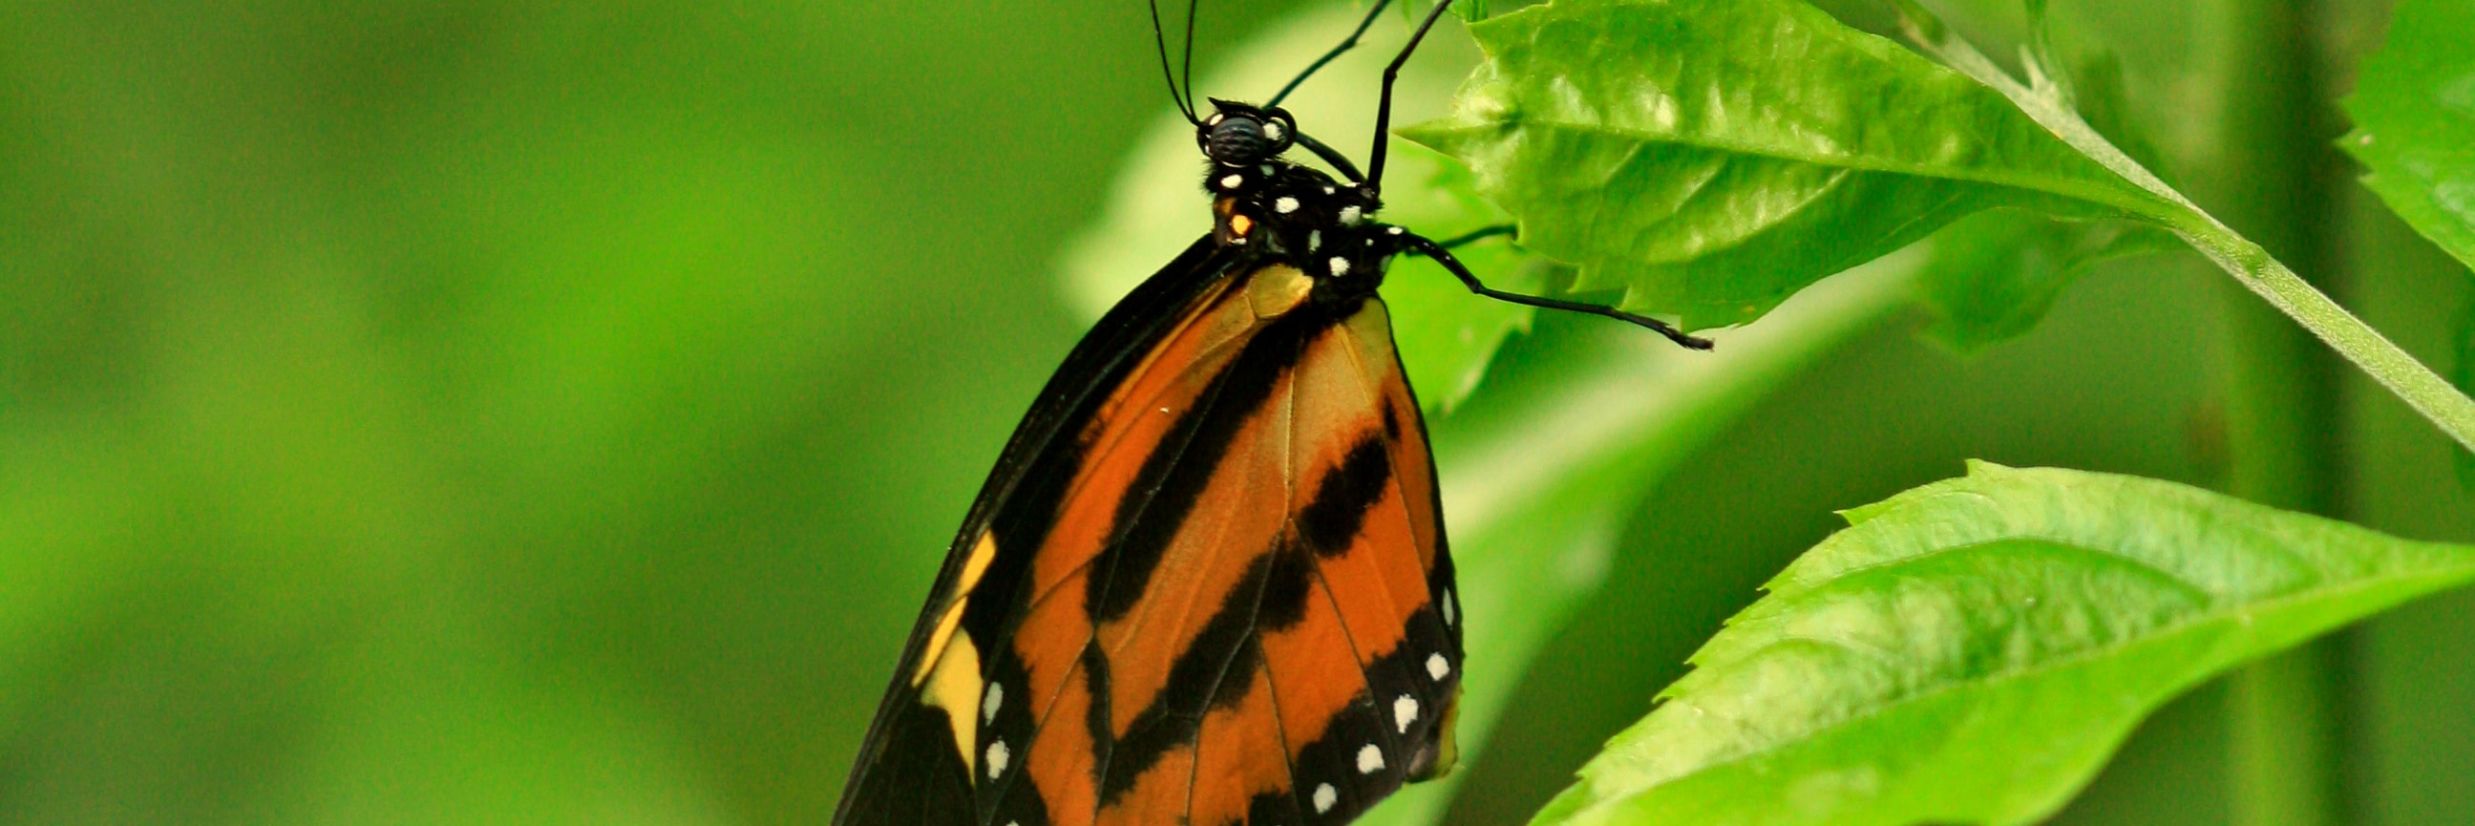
top-left (846, 254), bottom-right (1460, 826)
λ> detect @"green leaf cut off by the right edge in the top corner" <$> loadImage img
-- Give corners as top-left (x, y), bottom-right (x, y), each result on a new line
top-left (2341, 0), bottom-right (2475, 267)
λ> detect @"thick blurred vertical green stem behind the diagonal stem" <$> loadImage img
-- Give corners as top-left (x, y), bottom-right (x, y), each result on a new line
top-left (2185, 0), bottom-right (2346, 826)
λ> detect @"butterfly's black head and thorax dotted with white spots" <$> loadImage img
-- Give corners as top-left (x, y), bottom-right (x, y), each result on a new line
top-left (1195, 101), bottom-right (1403, 299)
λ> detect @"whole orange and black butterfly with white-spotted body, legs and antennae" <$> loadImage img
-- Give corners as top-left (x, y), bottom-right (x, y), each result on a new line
top-left (834, 0), bottom-right (1708, 826)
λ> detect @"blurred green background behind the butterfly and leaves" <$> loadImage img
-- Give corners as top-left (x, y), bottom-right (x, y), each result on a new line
top-left (0, 0), bottom-right (2475, 824)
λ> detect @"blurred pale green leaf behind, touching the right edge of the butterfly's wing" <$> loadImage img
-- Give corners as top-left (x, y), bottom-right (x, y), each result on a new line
top-left (1361, 233), bottom-right (1918, 826)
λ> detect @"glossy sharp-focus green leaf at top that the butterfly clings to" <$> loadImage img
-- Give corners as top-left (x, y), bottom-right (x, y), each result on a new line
top-left (1408, 0), bottom-right (2161, 326)
